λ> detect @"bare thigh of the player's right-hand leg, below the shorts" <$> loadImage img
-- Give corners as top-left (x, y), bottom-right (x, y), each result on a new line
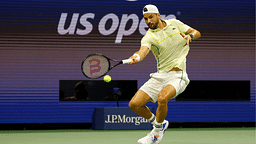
top-left (157, 84), bottom-right (176, 103)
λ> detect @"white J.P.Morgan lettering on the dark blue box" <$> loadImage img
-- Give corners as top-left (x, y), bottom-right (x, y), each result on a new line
top-left (105, 115), bottom-right (149, 125)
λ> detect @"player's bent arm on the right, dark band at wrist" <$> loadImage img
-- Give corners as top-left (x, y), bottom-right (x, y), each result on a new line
top-left (180, 28), bottom-right (201, 47)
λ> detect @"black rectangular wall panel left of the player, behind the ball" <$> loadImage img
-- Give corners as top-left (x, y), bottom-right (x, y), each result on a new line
top-left (60, 80), bottom-right (138, 101)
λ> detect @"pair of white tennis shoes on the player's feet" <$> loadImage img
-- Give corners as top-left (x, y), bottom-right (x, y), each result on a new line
top-left (138, 120), bottom-right (169, 144)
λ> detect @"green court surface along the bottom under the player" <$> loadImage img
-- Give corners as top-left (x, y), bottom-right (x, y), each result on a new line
top-left (0, 127), bottom-right (256, 144)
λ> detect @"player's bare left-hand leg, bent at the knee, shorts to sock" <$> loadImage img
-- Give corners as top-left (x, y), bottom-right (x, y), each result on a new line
top-left (129, 90), bottom-right (152, 119)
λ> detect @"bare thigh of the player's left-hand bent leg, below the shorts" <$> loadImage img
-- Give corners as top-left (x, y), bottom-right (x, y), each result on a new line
top-left (129, 89), bottom-right (152, 107)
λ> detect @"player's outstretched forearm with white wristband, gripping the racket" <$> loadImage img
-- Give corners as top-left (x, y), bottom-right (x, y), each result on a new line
top-left (129, 46), bottom-right (150, 65)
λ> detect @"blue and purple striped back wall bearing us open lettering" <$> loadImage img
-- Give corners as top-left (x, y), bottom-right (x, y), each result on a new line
top-left (0, 0), bottom-right (255, 123)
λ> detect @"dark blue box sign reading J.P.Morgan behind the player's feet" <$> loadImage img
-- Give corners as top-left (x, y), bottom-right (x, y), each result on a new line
top-left (92, 108), bottom-right (154, 130)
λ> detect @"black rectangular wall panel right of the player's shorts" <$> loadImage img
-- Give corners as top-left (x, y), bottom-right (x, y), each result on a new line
top-left (176, 80), bottom-right (250, 101)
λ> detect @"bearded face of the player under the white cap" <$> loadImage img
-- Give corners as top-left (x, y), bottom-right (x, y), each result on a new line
top-left (144, 13), bottom-right (160, 29)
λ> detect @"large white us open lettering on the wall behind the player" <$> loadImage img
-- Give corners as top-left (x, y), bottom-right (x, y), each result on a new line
top-left (57, 13), bottom-right (176, 44)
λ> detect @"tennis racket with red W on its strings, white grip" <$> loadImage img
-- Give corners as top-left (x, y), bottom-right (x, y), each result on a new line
top-left (81, 54), bottom-right (132, 79)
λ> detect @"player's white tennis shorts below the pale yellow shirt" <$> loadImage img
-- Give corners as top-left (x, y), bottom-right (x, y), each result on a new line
top-left (140, 71), bottom-right (190, 103)
